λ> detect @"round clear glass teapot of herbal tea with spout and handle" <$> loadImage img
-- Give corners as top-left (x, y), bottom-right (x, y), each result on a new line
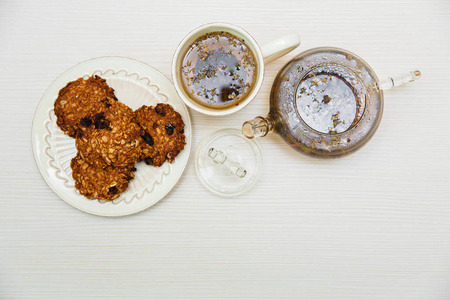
top-left (242, 47), bottom-right (421, 157)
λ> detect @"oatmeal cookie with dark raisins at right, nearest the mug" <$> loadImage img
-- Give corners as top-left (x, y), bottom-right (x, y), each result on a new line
top-left (135, 103), bottom-right (186, 167)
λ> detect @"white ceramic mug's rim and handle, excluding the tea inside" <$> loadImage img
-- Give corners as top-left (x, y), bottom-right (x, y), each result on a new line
top-left (172, 23), bottom-right (300, 116)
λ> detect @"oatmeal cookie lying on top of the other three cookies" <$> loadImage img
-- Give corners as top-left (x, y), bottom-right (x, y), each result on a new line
top-left (75, 99), bottom-right (142, 168)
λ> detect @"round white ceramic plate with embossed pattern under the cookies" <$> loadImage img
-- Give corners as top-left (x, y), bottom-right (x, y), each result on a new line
top-left (32, 57), bottom-right (192, 217)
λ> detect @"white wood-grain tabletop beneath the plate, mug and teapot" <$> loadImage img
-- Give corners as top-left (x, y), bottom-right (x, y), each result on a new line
top-left (0, 0), bottom-right (450, 300)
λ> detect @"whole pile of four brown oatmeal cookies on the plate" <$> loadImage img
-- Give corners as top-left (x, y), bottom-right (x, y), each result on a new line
top-left (54, 76), bottom-right (185, 201)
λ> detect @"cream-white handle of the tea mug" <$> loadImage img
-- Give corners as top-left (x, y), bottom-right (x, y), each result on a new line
top-left (261, 32), bottom-right (300, 63)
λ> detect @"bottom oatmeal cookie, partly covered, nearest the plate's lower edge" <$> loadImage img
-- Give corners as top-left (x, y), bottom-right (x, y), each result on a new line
top-left (70, 154), bottom-right (135, 201)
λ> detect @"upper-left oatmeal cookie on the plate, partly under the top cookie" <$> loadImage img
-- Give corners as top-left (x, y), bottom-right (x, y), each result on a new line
top-left (54, 75), bottom-right (117, 137)
